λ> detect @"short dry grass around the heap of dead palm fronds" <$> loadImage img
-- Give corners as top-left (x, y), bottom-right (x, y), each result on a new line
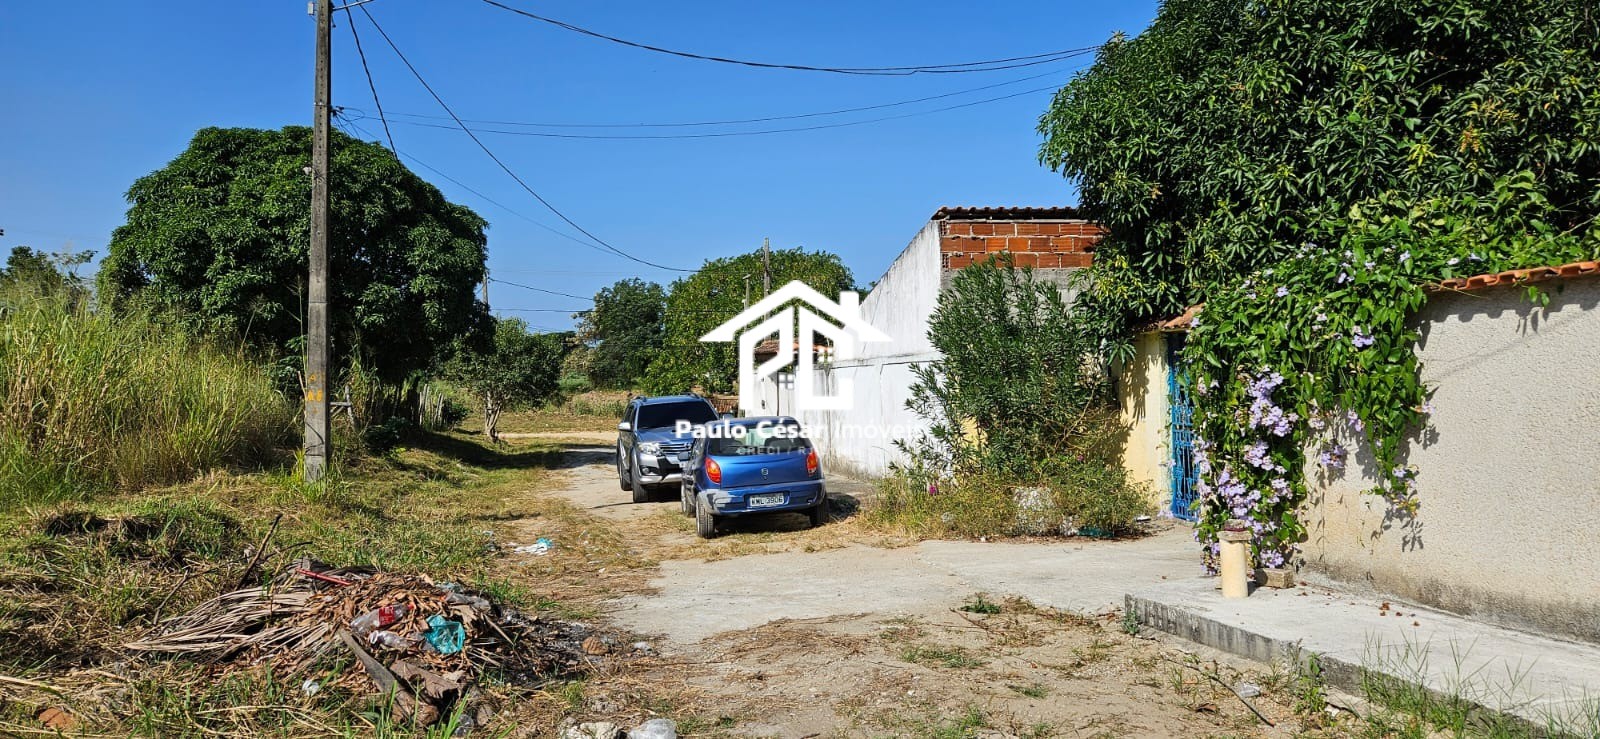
top-left (0, 435), bottom-right (624, 736)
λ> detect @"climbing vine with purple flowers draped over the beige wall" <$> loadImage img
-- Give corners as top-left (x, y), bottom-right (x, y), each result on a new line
top-left (1184, 176), bottom-right (1600, 568)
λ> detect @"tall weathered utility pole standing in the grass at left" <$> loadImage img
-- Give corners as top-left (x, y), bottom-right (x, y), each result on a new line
top-left (302, 0), bottom-right (333, 483)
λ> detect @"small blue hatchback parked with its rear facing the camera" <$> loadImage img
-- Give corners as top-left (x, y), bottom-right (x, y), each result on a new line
top-left (678, 416), bottom-right (829, 539)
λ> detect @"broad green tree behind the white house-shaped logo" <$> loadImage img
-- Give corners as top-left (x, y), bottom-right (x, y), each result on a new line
top-left (643, 248), bottom-right (854, 393)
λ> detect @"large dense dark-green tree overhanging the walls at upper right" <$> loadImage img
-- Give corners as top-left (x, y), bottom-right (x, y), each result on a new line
top-left (1040, 0), bottom-right (1600, 355)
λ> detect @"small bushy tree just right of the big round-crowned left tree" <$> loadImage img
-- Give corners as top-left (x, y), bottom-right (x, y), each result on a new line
top-left (445, 318), bottom-right (570, 441)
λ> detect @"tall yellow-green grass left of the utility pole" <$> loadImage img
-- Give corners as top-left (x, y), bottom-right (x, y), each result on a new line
top-left (0, 290), bottom-right (294, 510)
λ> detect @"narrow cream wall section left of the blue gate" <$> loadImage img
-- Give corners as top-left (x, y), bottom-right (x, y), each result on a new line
top-left (1117, 331), bottom-right (1173, 515)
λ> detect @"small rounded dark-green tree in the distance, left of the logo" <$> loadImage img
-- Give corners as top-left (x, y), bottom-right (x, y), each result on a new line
top-left (579, 277), bottom-right (667, 387)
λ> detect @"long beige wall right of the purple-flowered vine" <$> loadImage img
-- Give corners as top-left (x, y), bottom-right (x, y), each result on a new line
top-left (1302, 278), bottom-right (1600, 641)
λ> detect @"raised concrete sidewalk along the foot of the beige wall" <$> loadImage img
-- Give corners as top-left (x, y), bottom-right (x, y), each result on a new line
top-left (1126, 577), bottom-right (1600, 736)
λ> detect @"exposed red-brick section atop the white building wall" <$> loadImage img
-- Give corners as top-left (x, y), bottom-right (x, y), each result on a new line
top-left (939, 219), bottom-right (1106, 270)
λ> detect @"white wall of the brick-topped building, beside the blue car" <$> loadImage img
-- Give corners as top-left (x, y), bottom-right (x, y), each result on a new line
top-left (802, 221), bottom-right (941, 477)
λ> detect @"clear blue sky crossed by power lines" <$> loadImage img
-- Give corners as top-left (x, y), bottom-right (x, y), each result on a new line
top-left (0, 0), bottom-right (1155, 328)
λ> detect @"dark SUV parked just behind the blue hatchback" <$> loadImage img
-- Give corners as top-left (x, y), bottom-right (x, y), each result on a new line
top-left (616, 395), bottom-right (717, 502)
